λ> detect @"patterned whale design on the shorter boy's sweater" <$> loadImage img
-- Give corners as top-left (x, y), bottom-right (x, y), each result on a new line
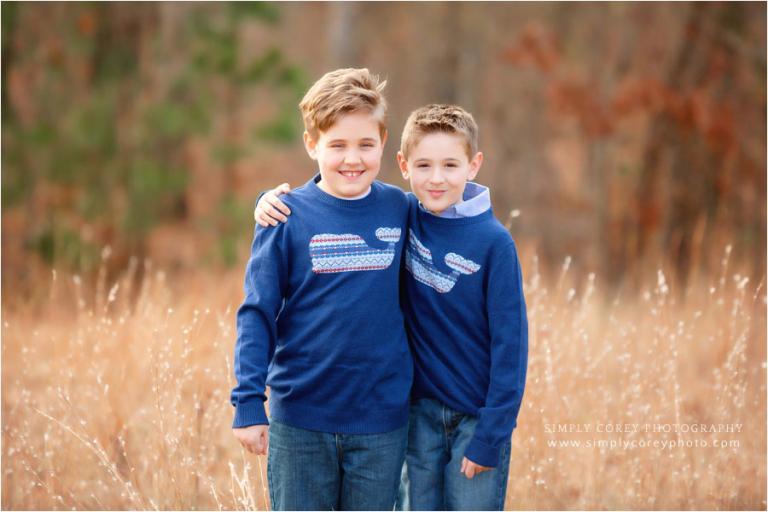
top-left (405, 230), bottom-right (480, 293)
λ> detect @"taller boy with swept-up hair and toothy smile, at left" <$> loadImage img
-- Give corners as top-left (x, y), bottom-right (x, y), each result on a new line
top-left (232, 69), bottom-right (413, 510)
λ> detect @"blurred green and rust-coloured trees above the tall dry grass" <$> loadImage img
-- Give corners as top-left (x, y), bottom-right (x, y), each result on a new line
top-left (2, 2), bottom-right (766, 297)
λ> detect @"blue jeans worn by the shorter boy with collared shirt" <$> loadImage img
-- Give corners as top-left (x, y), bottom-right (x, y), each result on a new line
top-left (397, 399), bottom-right (512, 510)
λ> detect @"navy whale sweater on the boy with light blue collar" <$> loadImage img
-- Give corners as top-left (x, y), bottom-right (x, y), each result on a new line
top-left (405, 194), bottom-right (528, 467)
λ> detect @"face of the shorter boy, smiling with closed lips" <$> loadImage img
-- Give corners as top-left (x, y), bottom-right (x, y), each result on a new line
top-left (397, 132), bottom-right (483, 214)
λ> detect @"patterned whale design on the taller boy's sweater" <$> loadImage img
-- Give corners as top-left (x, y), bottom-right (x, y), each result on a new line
top-left (309, 227), bottom-right (400, 274)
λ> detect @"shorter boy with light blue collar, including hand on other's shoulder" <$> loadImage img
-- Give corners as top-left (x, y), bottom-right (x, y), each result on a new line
top-left (257, 105), bottom-right (528, 510)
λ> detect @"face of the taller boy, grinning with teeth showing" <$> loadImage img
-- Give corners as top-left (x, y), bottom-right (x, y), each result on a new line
top-left (304, 112), bottom-right (387, 199)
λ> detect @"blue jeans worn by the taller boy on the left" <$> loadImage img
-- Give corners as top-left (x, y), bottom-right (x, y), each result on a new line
top-left (267, 419), bottom-right (408, 510)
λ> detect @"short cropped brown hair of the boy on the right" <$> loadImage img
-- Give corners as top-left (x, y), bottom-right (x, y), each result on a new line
top-left (400, 104), bottom-right (478, 160)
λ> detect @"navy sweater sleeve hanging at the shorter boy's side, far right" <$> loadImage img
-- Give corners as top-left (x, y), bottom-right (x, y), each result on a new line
top-left (465, 241), bottom-right (528, 467)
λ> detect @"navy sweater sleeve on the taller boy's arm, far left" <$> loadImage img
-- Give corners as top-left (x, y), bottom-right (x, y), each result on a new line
top-left (231, 224), bottom-right (288, 428)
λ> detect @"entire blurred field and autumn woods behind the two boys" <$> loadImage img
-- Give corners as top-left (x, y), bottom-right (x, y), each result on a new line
top-left (0, 2), bottom-right (768, 510)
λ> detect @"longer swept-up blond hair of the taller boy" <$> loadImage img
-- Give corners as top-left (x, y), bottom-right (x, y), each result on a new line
top-left (299, 68), bottom-right (387, 140)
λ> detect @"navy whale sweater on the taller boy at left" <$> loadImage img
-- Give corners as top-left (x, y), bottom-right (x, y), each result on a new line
top-left (231, 176), bottom-right (413, 434)
